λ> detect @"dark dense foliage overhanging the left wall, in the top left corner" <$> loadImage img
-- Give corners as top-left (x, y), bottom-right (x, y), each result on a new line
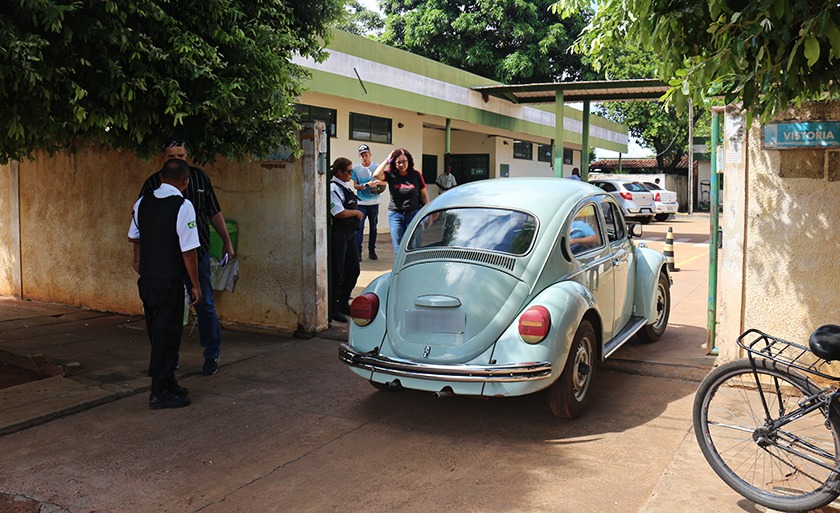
top-left (0, 0), bottom-right (341, 161)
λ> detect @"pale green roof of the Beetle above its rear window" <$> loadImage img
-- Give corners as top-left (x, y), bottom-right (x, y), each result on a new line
top-left (426, 178), bottom-right (606, 219)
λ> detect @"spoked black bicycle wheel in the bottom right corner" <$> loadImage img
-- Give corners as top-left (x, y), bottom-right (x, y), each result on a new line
top-left (694, 360), bottom-right (840, 511)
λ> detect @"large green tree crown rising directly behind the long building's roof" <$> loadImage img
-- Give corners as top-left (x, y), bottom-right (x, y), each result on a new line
top-left (380, 0), bottom-right (595, 84)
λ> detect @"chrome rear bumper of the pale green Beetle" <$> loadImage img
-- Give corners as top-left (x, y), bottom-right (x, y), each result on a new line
top-left (338, 343), bottom-right (551, 383)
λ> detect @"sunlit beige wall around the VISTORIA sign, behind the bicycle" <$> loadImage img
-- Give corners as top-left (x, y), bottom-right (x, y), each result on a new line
top-left (716, 102), bottom-right (840, 358)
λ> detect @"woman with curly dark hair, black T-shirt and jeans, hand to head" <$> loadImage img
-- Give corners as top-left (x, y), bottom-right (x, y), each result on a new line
top-left (373, 148), bottom-right (429, 255)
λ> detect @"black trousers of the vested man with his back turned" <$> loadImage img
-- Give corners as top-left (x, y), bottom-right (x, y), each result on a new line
top-left (137, 277), bottom-right (184, 380)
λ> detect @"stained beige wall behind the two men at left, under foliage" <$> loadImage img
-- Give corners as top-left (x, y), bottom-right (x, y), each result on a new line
top-left (0, 125), bottom-right (327, 329)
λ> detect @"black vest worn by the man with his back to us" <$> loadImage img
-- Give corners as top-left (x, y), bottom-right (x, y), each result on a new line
top-left (137, 192), bottom-right (187, 280)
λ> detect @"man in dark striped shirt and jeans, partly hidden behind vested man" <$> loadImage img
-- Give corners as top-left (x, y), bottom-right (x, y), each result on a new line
top-left (140, 140), bottom-right (233, 376)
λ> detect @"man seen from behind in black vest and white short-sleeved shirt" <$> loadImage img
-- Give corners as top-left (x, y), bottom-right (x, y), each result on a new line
top-left (128, 159), bottom-right (201, 410)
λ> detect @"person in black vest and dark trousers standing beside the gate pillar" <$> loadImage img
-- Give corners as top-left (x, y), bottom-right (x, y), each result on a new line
top-left (330, 157), bottom-right (364, 322)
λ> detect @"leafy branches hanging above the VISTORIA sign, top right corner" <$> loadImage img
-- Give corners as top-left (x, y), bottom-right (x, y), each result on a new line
top-left (552, 0), bottom-right (840, 119)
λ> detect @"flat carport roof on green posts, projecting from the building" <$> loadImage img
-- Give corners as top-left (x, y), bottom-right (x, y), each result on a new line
top-left (472, 79), bottom-right (670, 103)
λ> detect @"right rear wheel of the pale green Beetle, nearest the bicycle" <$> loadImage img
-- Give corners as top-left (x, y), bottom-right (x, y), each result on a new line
top-left (548, 320), bottom-right (597, 419)
